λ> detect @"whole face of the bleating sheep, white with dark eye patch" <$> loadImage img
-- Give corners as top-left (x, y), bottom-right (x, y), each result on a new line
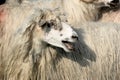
top-left (36, 19), bottom-right (78, 52)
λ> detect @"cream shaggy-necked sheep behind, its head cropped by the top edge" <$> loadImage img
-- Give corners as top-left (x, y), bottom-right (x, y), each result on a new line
top-left (7, 0), bottom-right (116, 27)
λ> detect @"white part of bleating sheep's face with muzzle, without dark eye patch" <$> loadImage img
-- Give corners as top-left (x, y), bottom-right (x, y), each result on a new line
top-left (44, 22), bottom-right (78, 52)
